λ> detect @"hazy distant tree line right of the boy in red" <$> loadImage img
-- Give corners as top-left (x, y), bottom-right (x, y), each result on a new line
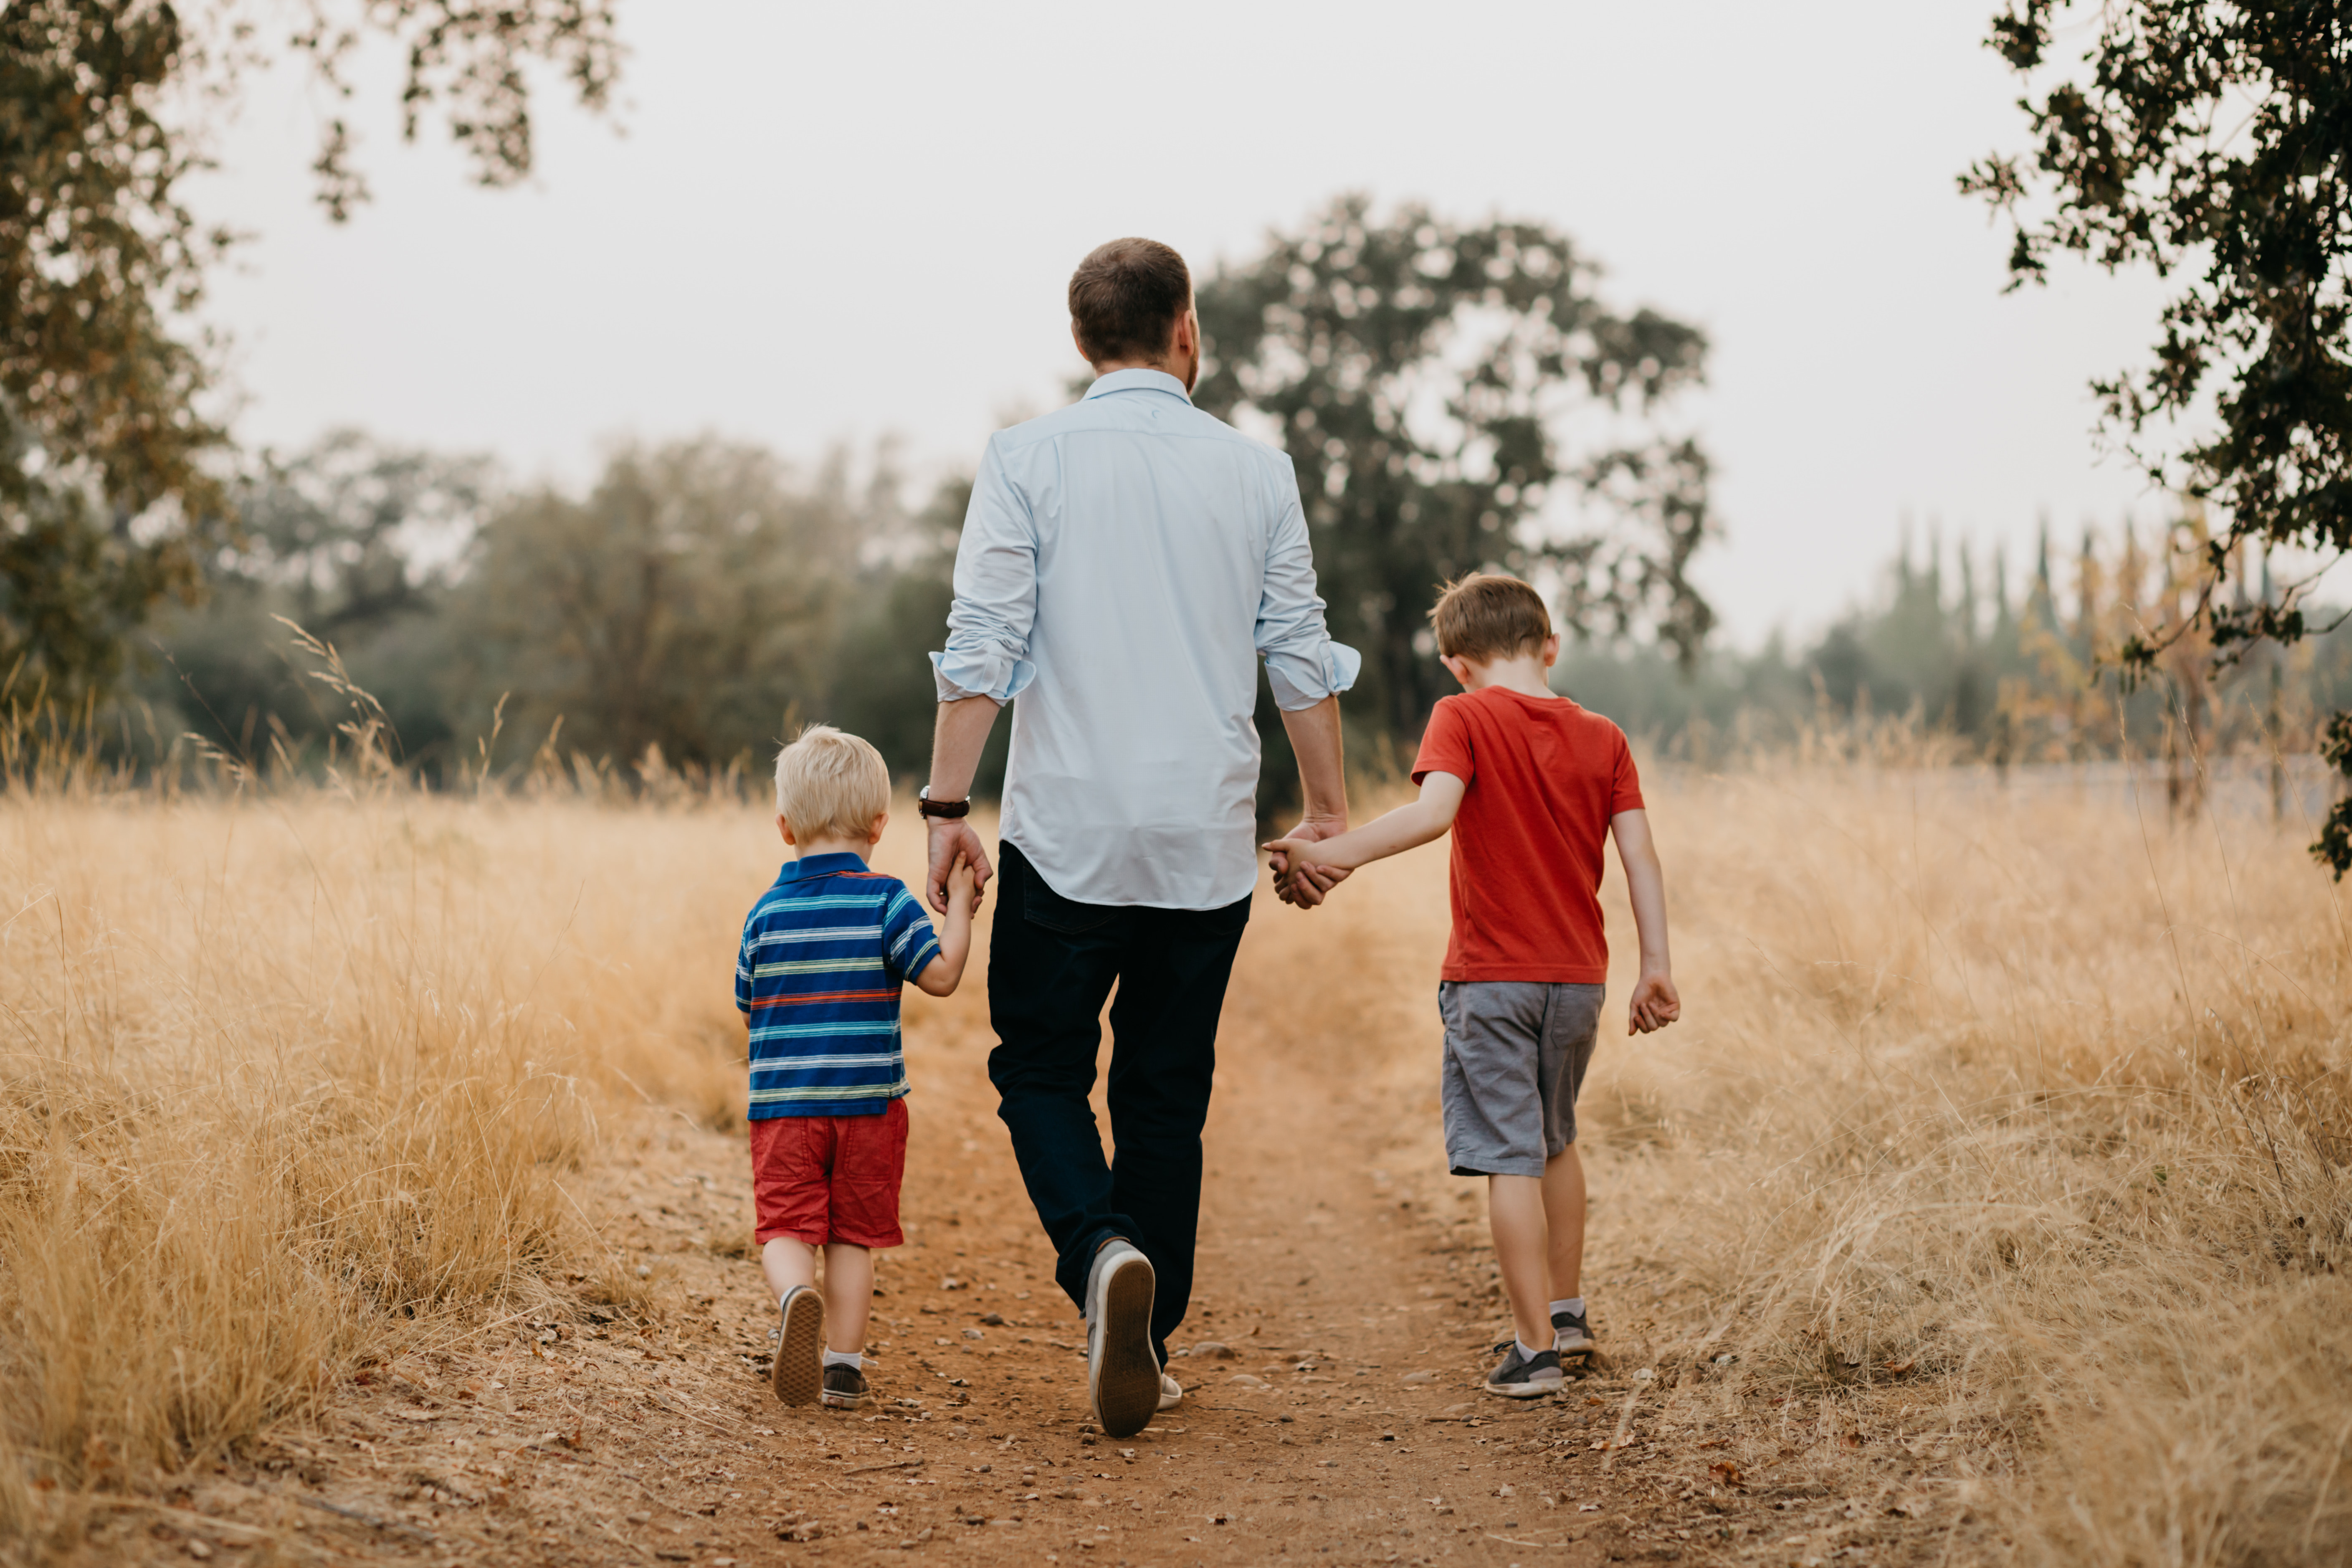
top-left (1554, 517), bottom-right (2352, 773)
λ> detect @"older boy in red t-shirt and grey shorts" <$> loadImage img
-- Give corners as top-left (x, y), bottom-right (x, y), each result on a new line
top-left (1268, 574), bottom-right (1682, 1399)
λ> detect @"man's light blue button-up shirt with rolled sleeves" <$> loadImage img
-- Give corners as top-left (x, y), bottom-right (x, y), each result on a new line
top-left (932, 369), bottom-right (1362, 910)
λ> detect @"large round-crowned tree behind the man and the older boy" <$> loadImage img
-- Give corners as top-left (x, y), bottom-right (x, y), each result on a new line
top-left (1195, 195), bottom-right (1714, 736)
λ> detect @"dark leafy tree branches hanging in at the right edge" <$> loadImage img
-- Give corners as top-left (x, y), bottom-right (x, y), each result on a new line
top-left (1959, 0), bottom-right (2352, 877)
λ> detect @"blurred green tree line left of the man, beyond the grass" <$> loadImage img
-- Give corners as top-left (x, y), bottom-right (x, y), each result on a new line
top-left (131, 430), bottom-right (1002, 788)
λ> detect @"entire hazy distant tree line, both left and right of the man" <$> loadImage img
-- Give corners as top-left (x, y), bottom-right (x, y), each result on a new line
top-left (101, 416), bottom-right (2324, 809)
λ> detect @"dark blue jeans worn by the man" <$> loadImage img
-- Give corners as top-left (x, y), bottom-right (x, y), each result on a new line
top-left (988, 844), bottom-right (1249, 1361)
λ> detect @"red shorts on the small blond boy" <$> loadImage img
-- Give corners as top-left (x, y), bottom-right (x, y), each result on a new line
top-left (750, 1095), bottom-right (906, 1246)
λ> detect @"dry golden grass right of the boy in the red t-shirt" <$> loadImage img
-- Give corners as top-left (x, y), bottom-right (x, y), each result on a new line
top-left (1587, 769), bottom-right (2352, 1565)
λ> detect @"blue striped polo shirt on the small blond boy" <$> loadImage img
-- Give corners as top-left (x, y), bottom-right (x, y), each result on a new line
top-left (736, 856), bottom-right (939, 1121)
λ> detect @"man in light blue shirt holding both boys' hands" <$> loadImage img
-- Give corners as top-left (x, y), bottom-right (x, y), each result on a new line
top-left (922, 240), bottom-right (1360, 1436)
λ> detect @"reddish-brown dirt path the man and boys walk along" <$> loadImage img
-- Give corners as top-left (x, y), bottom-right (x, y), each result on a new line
top-left (89, 869), bottom-right (1863, 1568)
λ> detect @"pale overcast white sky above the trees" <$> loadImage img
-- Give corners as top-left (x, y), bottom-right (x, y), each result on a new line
top-left (193, 0), bottom-right (2162, 642)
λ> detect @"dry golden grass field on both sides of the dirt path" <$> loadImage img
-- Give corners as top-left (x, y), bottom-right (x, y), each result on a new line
top-left (0, 764), bottom-right (2352, 1565)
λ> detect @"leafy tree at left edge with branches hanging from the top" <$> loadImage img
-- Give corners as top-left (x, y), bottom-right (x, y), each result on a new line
top-left (0, 0), bottom-right (618, 701)
